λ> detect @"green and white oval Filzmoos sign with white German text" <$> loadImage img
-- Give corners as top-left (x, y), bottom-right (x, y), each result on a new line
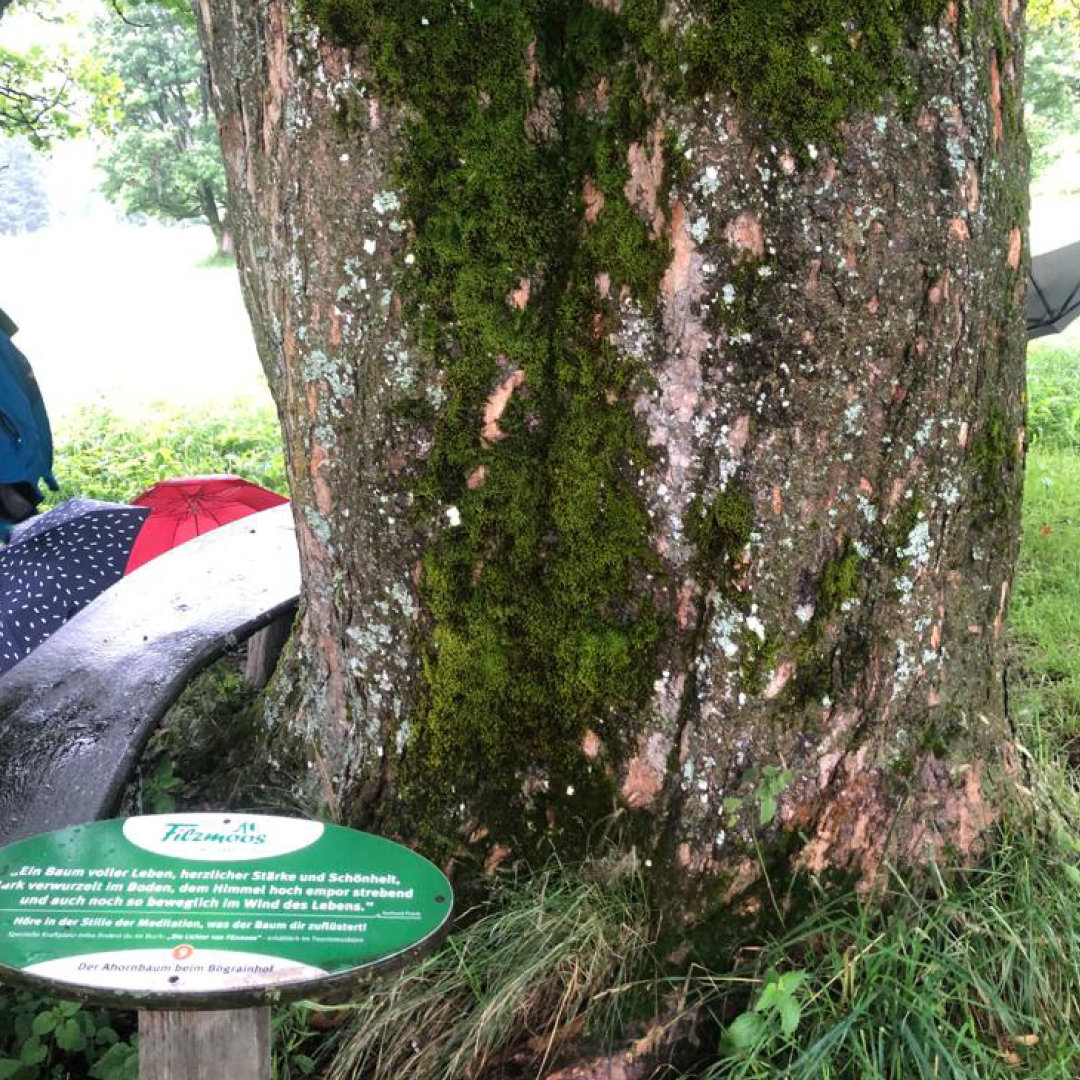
top-left (0, 813), bottom-right (454, 1008)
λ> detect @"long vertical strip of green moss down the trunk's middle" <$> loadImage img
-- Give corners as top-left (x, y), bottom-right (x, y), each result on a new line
top-left (295, 0), bottom-right (670, 850)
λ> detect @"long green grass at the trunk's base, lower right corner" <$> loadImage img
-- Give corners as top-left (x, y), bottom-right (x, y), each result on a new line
top-left (694, 761), bottom-right (1080, 1080)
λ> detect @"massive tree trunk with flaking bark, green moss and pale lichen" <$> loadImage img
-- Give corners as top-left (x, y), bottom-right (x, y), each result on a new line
top-left (197, 0), bottom-right (1027, 897)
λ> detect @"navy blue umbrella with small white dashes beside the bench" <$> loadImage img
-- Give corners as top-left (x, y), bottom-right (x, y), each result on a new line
top-left (0, 499), bottom-right (149, 674)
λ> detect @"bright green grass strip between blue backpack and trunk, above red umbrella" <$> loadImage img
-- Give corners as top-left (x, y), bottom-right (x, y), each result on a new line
top-left (50, 402), bottom-right (288, 503)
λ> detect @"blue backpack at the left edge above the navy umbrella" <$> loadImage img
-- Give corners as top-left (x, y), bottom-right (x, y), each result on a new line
top-left (0, 311), bottom-right (56, 535)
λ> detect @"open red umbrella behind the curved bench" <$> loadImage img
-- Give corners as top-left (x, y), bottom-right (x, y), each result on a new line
top-left (124, 476), bottom-right (288, 573)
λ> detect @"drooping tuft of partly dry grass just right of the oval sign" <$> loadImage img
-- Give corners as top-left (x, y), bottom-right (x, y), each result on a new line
top-left (326, 864), bottom-right (650, 1080)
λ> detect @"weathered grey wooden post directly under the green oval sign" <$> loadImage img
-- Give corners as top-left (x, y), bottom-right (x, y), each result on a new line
top-left (138, 1005), bottom-right (270, 1080)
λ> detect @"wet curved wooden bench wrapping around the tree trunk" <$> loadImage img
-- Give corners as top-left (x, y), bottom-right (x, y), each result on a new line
top-left (0, 505), bottom-right (300, 845)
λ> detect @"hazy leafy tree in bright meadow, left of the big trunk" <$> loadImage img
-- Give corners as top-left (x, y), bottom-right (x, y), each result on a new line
top-left (95, 3), bottom-right (232, 253)
